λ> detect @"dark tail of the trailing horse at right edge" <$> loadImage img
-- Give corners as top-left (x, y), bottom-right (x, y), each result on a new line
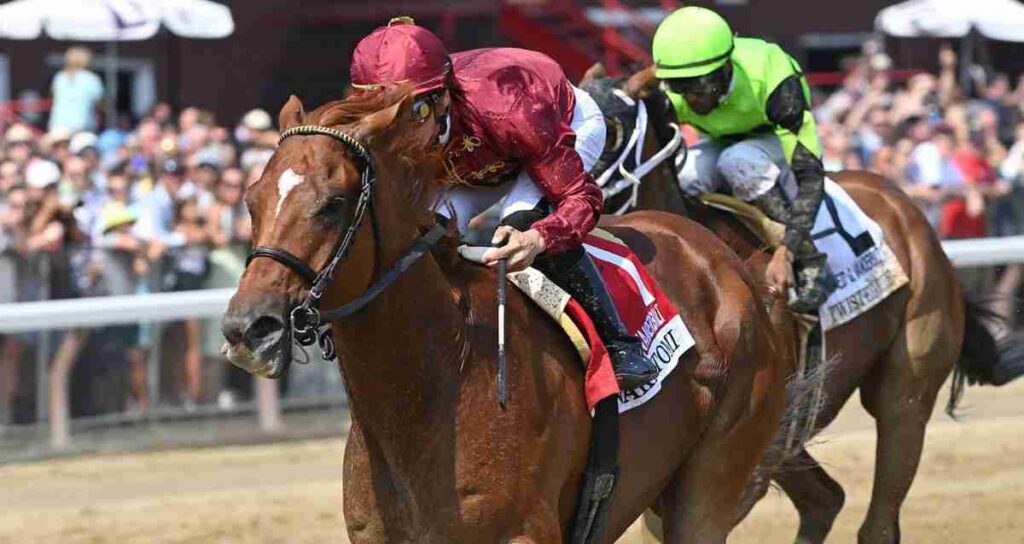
top-left (946, 297), bottom-right (1024, 417)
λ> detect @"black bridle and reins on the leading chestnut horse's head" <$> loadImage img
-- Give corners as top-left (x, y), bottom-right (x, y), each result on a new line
top-left (246, 125), bottom-right (445, 371)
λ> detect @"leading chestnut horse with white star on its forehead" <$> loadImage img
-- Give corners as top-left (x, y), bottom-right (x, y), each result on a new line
top-left (222, 87), bottom-right (786, 544)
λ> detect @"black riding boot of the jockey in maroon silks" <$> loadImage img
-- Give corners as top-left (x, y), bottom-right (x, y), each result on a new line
top-left (542, 252), bottom-right (658, 390)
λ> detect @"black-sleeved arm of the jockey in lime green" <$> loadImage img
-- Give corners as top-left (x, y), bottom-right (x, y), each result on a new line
top-left (766, 74), bottom-right (824, 251)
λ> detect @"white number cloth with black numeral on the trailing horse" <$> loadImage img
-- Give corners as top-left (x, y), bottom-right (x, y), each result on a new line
top-left (700, 178), bottom-right (909, 331)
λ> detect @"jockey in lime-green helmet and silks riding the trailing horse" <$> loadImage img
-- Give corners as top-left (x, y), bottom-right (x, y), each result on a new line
top-left (653, 6), bottom-right (835, 313)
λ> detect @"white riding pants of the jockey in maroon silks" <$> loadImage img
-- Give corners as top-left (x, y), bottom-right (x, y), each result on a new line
top-left (434, 87), bottom-right (606, 234)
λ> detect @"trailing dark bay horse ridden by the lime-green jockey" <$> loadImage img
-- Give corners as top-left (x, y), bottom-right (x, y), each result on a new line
top-left (581, 66), bottom-right (1024, 544)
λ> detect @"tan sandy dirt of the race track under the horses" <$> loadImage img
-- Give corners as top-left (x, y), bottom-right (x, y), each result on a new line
top-left (0, 383), bottom-right (1024, 544)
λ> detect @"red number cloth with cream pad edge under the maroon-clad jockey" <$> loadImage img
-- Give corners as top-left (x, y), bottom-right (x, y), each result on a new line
top-left (459, 231), bottom-right (694, 413)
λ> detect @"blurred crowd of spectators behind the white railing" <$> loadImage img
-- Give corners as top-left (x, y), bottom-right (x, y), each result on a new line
top-left (0, 36), bottom-right (1024, 425)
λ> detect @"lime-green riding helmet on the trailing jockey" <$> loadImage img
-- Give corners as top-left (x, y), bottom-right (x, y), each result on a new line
top-left (651, 6), bottom-right (733, 79)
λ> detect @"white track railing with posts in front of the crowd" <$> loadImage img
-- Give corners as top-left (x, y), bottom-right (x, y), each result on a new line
top-left (0, 236), bottom-right (1024, 449)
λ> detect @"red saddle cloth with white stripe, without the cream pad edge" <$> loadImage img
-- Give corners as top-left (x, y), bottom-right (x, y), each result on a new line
top-left (565, 234), bottom-right (693, 412)
